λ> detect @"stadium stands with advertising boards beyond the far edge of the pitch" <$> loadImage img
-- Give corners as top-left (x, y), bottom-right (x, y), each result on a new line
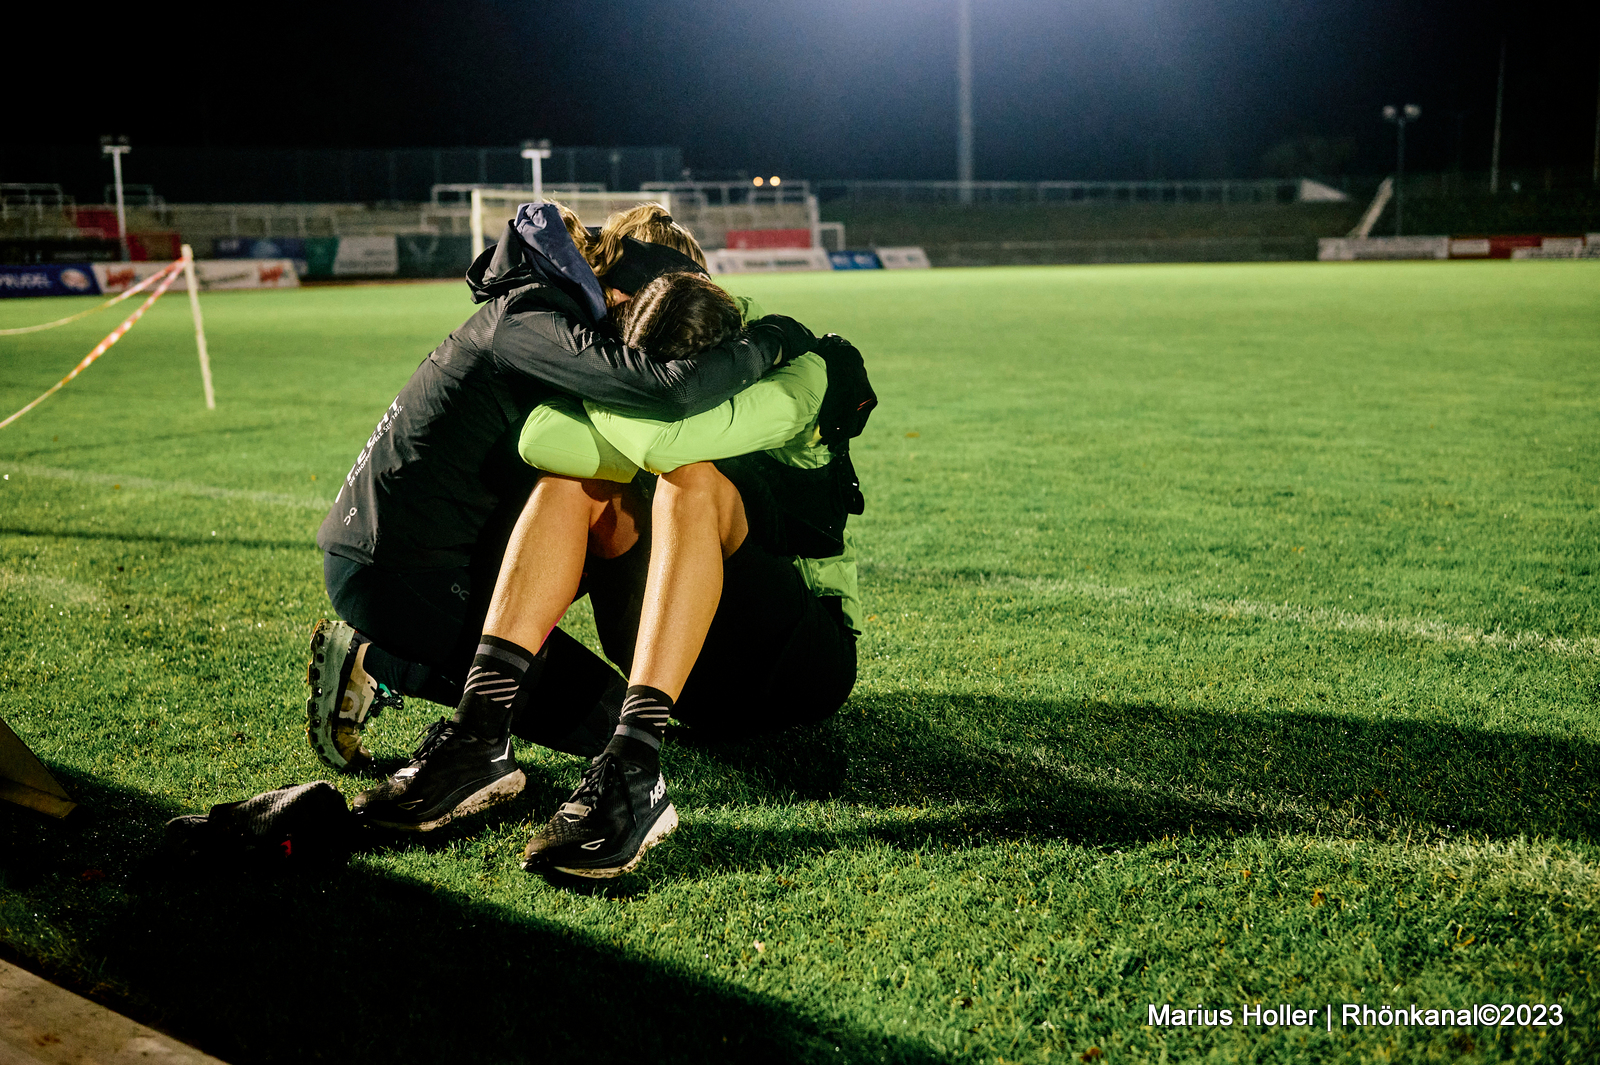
top-left (0, 146), bottom-right (1600, 280)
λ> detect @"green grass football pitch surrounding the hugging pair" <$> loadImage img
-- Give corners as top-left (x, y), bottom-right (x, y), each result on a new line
top-left (0, 262), bottom-right (1600, 1065)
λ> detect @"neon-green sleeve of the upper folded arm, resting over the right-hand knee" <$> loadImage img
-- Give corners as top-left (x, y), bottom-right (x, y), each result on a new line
top-left (584, 355), bottom-right (827, 473)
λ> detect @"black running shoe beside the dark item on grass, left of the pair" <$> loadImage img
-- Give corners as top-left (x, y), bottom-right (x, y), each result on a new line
top-left (350, 721), bottom-right (526, 832)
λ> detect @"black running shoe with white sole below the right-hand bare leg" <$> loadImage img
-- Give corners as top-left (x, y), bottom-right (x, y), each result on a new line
top-left (522, 755), bottom-right (678, 878)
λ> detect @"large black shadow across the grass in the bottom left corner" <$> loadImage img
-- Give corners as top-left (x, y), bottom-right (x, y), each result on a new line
top-left (0, 769), bottom-right (941, 1065)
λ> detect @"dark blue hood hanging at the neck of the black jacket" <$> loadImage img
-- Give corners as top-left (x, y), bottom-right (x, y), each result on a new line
top-left (467, 203), bottom-right (606, 325)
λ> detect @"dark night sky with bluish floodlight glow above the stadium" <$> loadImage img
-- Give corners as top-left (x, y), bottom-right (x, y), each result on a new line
top-left (15, 0), bottom-right (1600, 179)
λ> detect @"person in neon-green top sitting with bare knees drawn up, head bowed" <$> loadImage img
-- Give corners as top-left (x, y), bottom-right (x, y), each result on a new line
top-left (355, 275), bottom-right (875, 876)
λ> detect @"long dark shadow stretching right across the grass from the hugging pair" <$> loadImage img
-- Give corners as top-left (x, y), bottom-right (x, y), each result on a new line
top-left (652, 692), bottom-right (1600, 872)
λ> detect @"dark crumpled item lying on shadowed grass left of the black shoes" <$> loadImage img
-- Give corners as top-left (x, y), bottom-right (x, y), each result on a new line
top-left (166, 780), bottom-right (355, 868)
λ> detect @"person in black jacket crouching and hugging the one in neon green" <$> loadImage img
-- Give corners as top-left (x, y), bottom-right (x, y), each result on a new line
top-left (307, 203), bottom-right (811, 772)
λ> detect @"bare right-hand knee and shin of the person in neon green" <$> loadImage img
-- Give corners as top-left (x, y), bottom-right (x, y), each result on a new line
top-left (627, 462), bottom-right (750, 699)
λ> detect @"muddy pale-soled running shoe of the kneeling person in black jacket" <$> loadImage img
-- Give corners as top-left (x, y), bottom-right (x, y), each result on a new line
top-left (306, 617), bottom-right (402, 772)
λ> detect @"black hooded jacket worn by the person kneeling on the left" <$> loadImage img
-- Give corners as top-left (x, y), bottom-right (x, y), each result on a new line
top-left (317, 214), bottom-right (782, 569)
